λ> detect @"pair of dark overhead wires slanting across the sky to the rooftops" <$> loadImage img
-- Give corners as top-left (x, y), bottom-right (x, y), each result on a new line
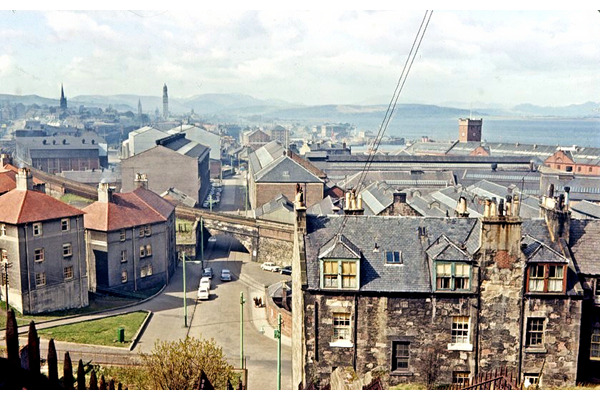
top-left (338, 10), bottom-right (433, 235)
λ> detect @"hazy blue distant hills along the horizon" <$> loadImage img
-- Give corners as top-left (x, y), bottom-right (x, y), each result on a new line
top-left (0, 93), bottom-right (600, 123)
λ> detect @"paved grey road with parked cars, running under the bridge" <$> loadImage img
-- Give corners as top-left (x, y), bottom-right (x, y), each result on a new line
top-left (0, 173), bottom-right (292, 390)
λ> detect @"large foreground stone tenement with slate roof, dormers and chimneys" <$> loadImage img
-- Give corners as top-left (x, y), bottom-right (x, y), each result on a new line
top-left (292, 187), bottom-right (600, 387)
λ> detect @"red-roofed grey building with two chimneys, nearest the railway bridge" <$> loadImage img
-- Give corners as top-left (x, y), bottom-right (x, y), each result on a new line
top-left (83, 174), bottom-right (177, 292)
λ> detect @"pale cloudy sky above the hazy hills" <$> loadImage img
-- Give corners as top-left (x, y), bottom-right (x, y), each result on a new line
top-left (0, 10), bottom-right (600, 106)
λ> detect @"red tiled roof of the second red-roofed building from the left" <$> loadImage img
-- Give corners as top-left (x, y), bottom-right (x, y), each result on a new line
top-left (83, 188), bottom-right (175, 232)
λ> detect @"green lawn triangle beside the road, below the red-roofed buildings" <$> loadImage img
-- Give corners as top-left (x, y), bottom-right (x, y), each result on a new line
top-left (38, 311), bottom-right (148, 347)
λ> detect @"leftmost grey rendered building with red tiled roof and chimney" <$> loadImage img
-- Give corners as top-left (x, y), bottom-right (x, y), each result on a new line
top-left (0, 168), bottom-right (89, 314)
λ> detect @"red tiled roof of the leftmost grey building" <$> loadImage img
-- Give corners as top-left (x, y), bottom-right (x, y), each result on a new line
top-left (0, 189), bottom-right (84, 224)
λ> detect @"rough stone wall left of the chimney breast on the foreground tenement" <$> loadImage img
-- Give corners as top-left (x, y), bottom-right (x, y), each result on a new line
top-left (304, 294), bottom-right (477, 385)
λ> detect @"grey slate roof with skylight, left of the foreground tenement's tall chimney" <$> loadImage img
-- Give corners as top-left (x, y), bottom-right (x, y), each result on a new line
top-left (305, 215), bottom-right (478, 293)
